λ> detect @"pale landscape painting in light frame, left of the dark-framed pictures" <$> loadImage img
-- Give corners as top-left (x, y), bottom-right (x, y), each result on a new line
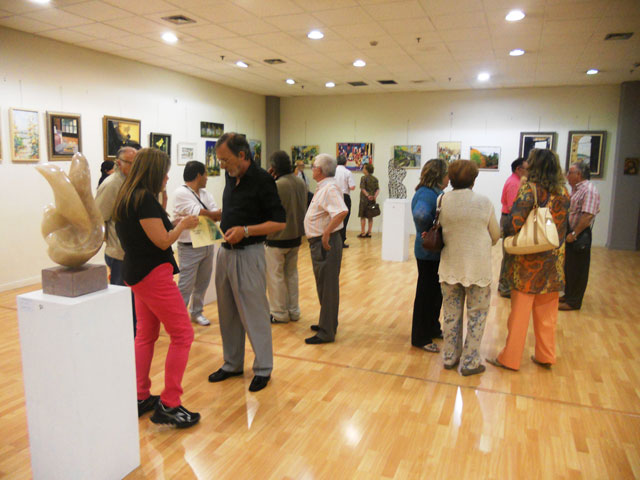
top-left (9, 108), bottom-right (40, 162)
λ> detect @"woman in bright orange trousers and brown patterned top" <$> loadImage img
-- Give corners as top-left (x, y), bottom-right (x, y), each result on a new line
top-left (487, 149), bottom-right (570, 370)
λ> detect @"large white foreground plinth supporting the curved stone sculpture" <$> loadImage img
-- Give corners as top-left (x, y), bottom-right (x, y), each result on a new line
top-left (17, 285), bottom-right (140, 480)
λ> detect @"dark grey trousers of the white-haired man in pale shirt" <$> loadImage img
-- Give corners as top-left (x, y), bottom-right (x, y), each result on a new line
top-left (309, 230), bottom-right (342, 341)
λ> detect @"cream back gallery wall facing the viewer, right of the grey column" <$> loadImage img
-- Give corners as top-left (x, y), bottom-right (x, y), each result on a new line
top-left (280, 85), bottom-right (620, 245)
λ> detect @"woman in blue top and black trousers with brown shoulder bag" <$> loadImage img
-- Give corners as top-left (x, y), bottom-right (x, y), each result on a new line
top-left (411, 158), bottom-right (449, 353)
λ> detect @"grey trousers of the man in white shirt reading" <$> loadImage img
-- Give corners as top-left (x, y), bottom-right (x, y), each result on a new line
top-left (178, 243), bottom-right (213, 318)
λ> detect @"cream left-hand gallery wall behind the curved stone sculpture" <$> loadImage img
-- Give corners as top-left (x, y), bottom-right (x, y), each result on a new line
top-left (0, 28), bottom-right (265, 291)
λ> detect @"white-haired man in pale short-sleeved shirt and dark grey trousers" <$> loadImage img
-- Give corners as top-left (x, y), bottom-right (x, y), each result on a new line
top-left (304, 153), bottom-right (348, 345)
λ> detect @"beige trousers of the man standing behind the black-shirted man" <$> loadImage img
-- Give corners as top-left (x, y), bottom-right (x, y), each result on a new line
top-left (264, 247), bottom-right (300, 322)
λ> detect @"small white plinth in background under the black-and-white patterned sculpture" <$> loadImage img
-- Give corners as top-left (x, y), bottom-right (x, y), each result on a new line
top-left (382, 198), bottom-right (411, 262)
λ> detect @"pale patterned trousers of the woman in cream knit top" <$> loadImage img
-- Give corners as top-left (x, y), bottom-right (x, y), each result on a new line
top-left (440, 282), bottom-right (491, 369)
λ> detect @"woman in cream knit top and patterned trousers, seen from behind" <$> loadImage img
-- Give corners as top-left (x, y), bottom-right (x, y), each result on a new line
top-left (438, 160), bottom-right (500, 376)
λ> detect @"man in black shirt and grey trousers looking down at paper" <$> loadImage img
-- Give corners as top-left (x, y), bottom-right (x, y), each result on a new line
top-left (209, 133), bottom-right (286, 392)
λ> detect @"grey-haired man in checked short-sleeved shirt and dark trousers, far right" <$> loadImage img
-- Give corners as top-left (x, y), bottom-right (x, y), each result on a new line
top-left (558, 161), bottom-right (600, 310)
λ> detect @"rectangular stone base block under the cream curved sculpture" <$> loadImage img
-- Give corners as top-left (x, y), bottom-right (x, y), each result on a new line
top-left (42, 263), bottom-right (108, 297)
